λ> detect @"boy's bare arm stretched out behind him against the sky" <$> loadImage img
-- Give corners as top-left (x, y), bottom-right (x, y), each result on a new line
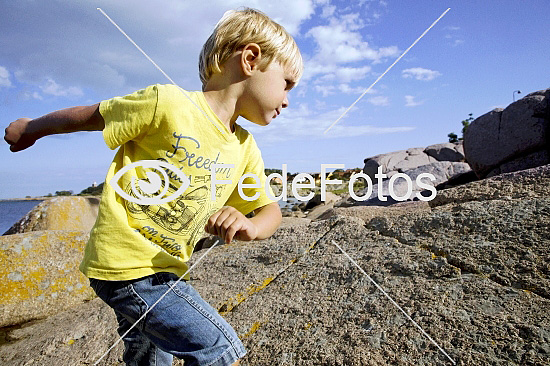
top-left (4, 103), bottom-right (105, 152)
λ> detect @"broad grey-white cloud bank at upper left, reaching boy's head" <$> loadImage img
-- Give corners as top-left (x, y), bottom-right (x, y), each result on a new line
top-left (0, 0), bottom-right (317, 98)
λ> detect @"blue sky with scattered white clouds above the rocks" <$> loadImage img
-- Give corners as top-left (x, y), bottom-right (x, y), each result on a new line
top-left (0, 0), bottom-right (550, 199)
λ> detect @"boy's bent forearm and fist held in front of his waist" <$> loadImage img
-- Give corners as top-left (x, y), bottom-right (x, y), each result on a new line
top-left (204, 202), bottom-right (282, 244)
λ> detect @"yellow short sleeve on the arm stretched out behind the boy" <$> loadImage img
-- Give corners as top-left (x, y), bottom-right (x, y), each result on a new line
top-left (99, 85), bottom-right (159, 150)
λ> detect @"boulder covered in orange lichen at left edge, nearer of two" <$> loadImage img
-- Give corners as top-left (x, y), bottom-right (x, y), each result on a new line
top-left (0, 231), bottom-right (93, 326)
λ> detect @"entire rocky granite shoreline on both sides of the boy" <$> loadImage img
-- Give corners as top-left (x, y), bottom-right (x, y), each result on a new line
top-left (0, 92), bottom-right (550, 366)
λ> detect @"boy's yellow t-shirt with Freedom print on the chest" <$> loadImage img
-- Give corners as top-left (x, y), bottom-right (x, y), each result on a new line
top-left (80, 85), bottom-right (273, 281)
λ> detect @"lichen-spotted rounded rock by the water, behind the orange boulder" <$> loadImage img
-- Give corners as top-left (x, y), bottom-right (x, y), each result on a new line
top-left (4, 196), bottom-right (99, 235)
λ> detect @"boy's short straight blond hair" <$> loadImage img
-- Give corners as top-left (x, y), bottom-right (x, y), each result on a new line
top-left (199, 8), bottom-right (303, 87)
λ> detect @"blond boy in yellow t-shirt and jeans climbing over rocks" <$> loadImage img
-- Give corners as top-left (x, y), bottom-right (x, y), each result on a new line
top-left (4, 8), bottom-right (303, 366)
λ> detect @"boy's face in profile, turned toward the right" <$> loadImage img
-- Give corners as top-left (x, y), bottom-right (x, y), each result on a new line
top-left (241, 61), bottom-right (295, 126)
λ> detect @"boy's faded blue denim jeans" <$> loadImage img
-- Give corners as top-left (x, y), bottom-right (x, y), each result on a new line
top-left (90, 272), bottom-right (246, 366)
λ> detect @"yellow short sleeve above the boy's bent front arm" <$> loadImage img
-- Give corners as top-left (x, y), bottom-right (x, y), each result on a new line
top-left (226, 139), bottom-right (276, 215)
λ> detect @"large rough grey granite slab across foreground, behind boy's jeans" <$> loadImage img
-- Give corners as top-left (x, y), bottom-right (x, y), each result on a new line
top-left (0, 169), bottom-right (550, 366)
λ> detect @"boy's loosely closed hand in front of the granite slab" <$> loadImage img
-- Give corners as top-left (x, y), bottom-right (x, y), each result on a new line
top-left (204, 206), bottom-right (258, 244)
